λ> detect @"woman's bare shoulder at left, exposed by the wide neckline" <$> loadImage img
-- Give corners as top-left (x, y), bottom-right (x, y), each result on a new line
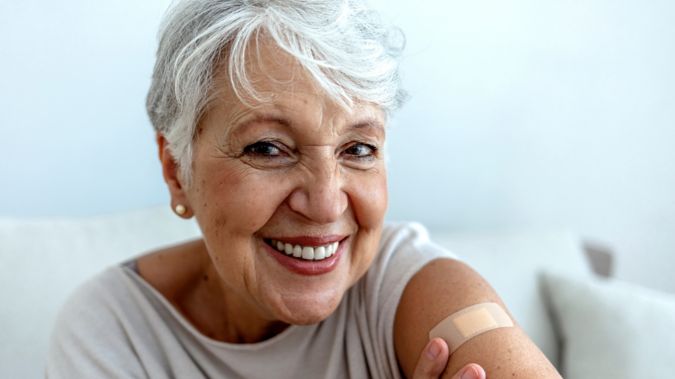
top-left (136, 239), bottom-right (206, 302)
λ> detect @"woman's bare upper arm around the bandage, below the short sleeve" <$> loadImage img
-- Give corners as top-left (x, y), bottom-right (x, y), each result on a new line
top-left (394, 259), bottom-right (560, 379)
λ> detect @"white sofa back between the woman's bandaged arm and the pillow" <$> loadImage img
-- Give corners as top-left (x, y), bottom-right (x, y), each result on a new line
top-left (432, 230), bottom-right (591, 367)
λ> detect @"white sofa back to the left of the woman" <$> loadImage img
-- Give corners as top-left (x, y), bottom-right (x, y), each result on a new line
top-left (0, 207), bottom-right (199, 378)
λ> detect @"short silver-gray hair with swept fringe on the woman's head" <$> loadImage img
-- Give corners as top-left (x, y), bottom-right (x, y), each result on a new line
top-left (146, 0), bottom-right (405, 185)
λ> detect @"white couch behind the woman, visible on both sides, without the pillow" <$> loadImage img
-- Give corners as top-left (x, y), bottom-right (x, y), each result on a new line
top-left (0, 207), bottom-right (616, 378)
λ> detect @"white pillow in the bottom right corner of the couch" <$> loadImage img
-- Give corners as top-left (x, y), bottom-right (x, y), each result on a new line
top-left (542, 273), bottom-right (675, 379)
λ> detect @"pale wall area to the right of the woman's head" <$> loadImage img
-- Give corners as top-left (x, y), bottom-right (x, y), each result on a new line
top-left (378, 0), bottom-right (675, 291)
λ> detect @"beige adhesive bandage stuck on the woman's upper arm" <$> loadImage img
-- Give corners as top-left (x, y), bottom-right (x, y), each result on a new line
top-left (429, 303), bottom-right (513, 353)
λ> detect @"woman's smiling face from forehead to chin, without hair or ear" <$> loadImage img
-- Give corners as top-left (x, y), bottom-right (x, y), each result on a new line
top-left (174, 43), bottom-right (387, 324)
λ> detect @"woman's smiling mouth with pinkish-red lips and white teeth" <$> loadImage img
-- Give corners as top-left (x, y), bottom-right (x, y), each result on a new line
top-left (264, 236), bottom-right (348, 275)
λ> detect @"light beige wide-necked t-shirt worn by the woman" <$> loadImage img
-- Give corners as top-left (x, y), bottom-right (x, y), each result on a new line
top-left (47, 224), bottom-right (452, 379)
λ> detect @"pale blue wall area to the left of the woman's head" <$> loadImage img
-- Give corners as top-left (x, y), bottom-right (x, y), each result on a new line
top-left (0, 0), bottom-right (174, 216)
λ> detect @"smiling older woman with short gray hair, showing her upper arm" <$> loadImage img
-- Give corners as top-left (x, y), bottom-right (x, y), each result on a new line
top-left (47, 0), bottom-right (559, 378)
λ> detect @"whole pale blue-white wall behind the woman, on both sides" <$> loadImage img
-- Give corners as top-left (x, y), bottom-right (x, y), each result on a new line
top-left (0, 0), bottom-right (675, 292)
